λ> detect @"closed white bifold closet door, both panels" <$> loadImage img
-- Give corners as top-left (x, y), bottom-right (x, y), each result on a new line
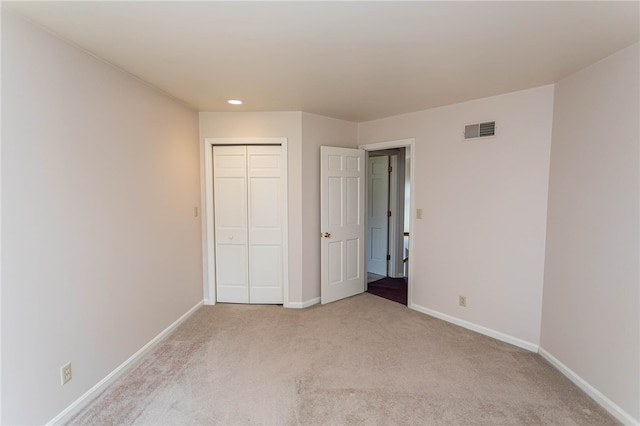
top-left (213, 145), bottom-right (284, 304)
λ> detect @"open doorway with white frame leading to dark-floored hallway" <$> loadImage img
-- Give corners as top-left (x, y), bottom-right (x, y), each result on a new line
top-left (360, 140), bottom-right (413, 305)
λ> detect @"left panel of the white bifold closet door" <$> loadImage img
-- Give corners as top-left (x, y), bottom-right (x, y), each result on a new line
top-left (213, 146), bottom-right (249, 303)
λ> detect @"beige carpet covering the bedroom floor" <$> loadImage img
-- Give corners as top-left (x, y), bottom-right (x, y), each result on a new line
top-left (71, 293), bottom-right (617, 425)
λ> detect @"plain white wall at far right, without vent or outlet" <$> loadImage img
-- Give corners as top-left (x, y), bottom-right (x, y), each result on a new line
top-left (541, 44), bottom-right (640, 422)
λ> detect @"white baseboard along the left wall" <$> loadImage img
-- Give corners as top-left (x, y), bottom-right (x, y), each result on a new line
top-left (47, 301), bottom-right (204, 426)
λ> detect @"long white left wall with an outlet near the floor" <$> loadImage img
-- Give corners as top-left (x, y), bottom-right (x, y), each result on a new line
top-left (2, 11), bottom-right (202, 424)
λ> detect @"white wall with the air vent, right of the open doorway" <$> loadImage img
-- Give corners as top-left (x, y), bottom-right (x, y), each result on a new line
top-left (358, 86), bottom-right (553, 350)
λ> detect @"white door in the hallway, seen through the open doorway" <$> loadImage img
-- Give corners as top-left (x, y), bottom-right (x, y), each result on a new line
top-left (367, 155), bottom-right (389, 276)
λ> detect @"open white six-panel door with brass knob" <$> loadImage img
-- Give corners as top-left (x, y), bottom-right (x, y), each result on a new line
top-left (320, 146), bottom-right (366, 303)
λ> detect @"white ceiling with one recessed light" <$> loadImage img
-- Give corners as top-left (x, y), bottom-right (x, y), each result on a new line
top-left (3, 1), bottom-right (640, 122)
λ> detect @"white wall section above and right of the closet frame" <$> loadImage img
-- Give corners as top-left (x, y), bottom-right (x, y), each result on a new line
top-left (200, 112), bottom-right (303, 303)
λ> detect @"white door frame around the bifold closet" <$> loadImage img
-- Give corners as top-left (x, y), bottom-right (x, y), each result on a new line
top-left (200, 138), bottom-right (288, 306)
